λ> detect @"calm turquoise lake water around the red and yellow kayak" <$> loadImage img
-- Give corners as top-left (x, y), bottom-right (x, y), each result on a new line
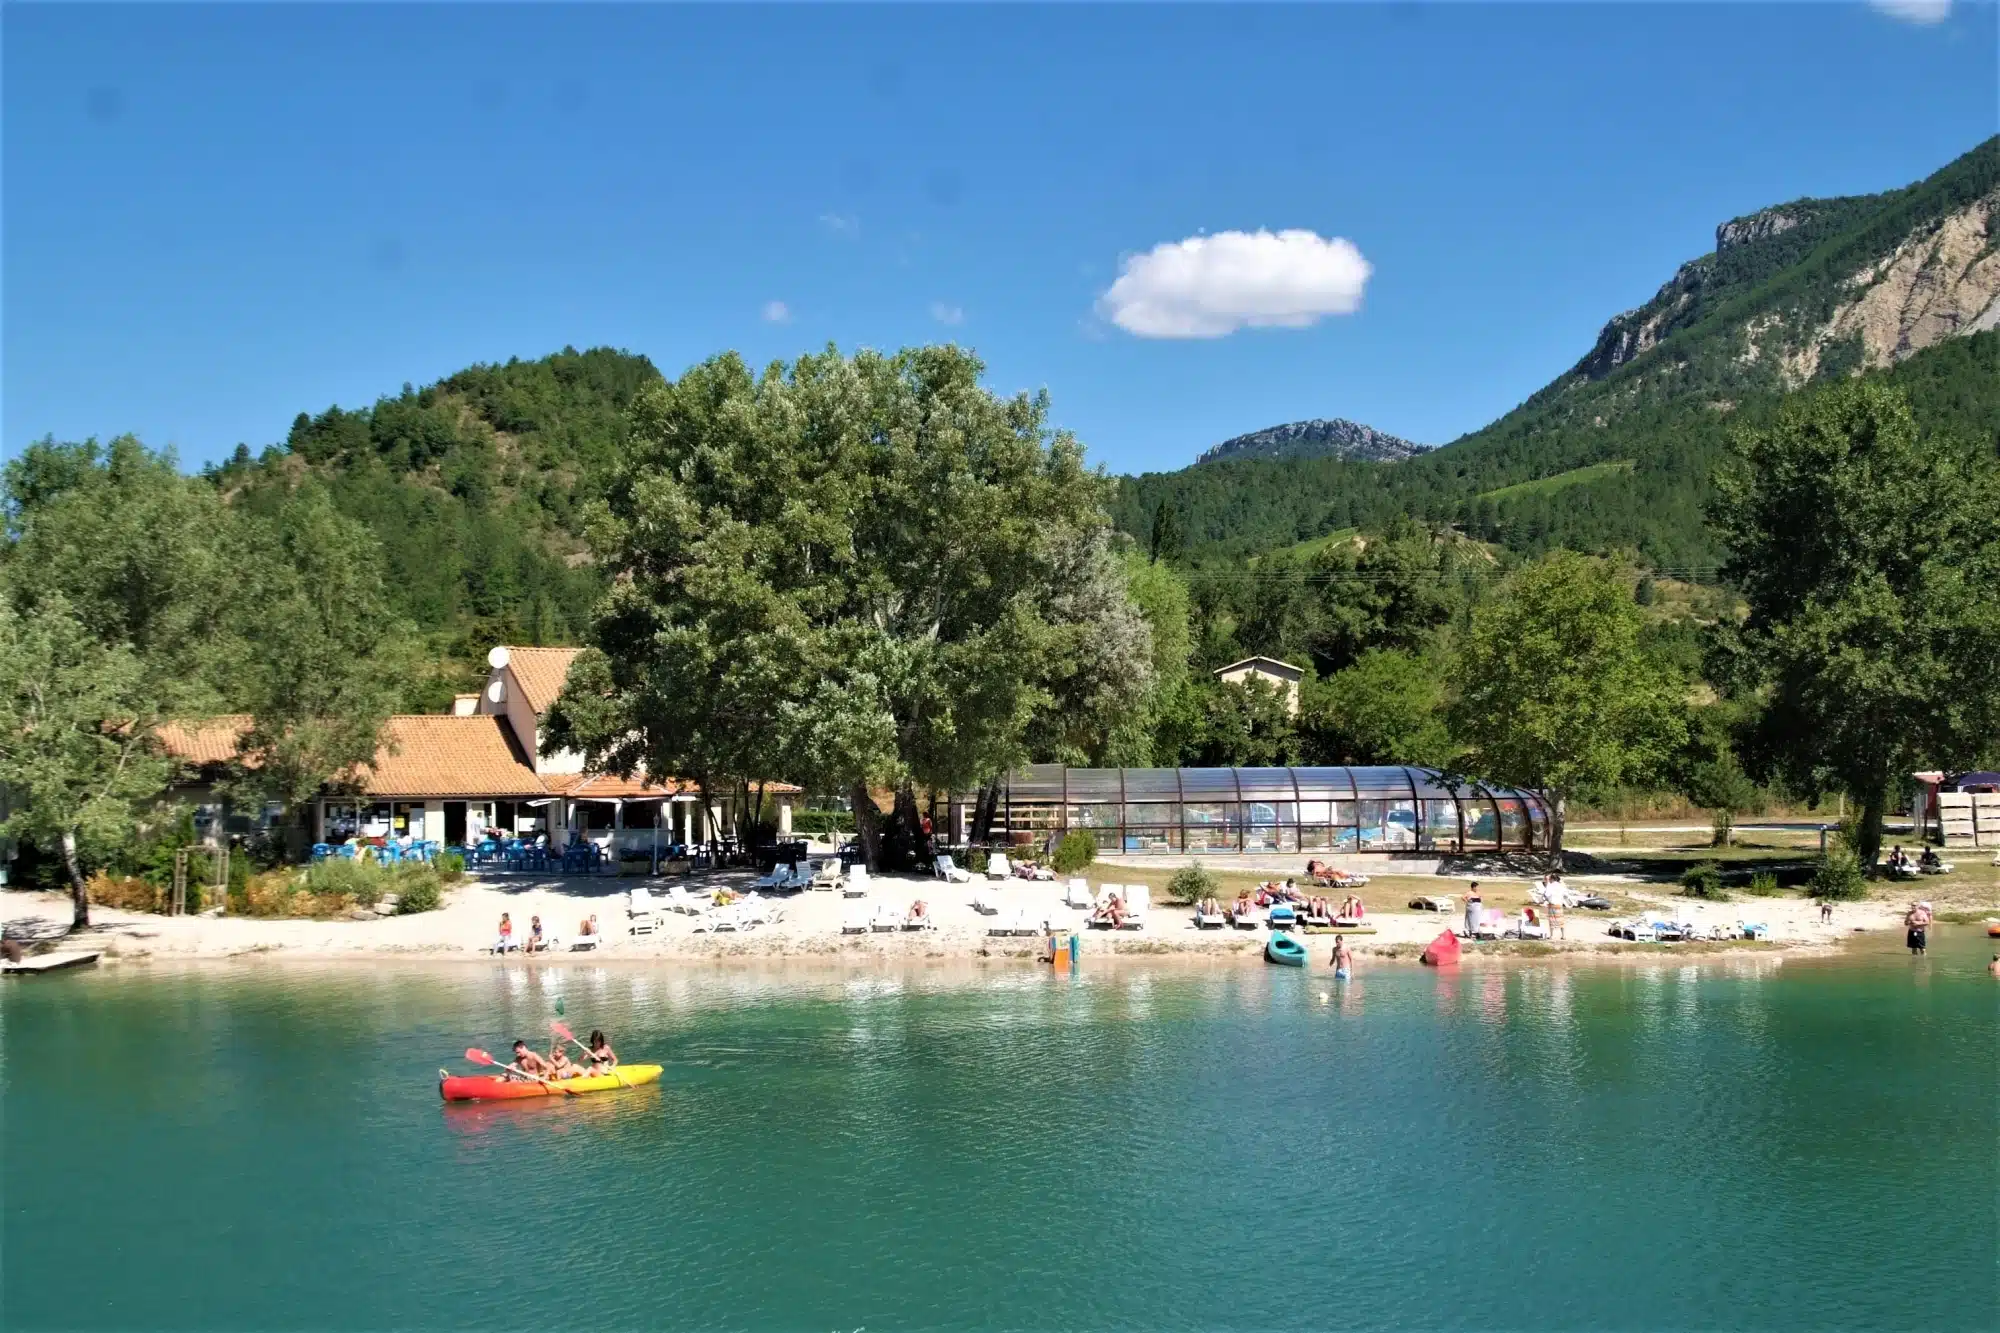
top-left (0, 933), bottom-right (2000, 1331)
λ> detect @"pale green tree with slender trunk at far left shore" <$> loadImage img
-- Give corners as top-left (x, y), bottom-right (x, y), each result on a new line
top-left (0, 592), bottom-right (172, 929)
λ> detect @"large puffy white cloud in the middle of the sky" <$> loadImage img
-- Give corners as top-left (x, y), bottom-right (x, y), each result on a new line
top-left (1098, 230), bottom-right (1374, 338)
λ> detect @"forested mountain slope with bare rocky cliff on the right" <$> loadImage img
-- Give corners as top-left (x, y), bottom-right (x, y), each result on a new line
top-left (1114, 136), bottom-right (2000, 568)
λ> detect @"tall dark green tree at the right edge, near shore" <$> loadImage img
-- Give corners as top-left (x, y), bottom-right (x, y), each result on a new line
top-left (1712, 380), bottom-right (2000, 865)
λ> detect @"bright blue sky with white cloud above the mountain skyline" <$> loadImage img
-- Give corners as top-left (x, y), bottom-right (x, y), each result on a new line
top-left (0, 0), bottom-right (2000, 470)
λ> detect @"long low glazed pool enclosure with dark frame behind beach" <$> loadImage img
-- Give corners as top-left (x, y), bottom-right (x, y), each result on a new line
top-left (994, 765), bottom-right (1550, 855)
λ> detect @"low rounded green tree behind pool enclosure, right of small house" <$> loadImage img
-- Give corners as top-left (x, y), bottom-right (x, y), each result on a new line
top-left (1304, 648), bottom-right (1458, 769)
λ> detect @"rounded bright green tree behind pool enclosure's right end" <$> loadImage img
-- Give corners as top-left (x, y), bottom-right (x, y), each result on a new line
top-left (1450, 550), bottom-right (1688, 857)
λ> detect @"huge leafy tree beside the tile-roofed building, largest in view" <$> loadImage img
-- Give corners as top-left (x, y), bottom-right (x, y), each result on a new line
top-left (550, 346), bottom-right (1150, 861)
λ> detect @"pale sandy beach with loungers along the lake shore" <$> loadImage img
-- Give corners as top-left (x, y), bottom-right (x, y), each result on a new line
top-left (0, 844), bottom-right (1950, 965)
